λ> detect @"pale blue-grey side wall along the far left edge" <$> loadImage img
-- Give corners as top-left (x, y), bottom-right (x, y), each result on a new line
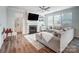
top-left (0, 6), bottom-right (7, 48)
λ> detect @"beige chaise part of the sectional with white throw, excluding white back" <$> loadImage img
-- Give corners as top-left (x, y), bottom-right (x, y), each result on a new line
top-left (36, 32), bottom-right (60, 52)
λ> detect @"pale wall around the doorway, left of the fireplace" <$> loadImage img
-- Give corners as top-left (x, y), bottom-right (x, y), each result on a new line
top-left (7, 7), bottom-right (25, 33)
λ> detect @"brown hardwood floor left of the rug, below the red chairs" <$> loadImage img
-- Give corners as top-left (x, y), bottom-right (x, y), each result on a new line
top-left (0, 34), bottom-right (55, 53)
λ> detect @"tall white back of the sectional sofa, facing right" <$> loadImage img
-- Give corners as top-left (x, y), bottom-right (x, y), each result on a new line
top-left (60, 28), bottom-right (74, 52)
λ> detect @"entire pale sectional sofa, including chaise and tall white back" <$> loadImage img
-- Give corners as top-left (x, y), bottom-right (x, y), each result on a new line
top-left (36, 28), bottom-right (74, 52)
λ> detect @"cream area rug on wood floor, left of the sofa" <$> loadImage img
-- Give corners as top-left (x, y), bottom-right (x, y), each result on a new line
top-left (24, 34), bottom-right (45, 50)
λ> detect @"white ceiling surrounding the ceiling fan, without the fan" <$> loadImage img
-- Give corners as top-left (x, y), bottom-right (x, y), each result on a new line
top-left (10, 6), bottom-right (72, 15)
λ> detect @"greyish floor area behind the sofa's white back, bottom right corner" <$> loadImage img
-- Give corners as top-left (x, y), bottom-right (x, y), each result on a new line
top-left (63, 38), bottom-right (79, 53)
